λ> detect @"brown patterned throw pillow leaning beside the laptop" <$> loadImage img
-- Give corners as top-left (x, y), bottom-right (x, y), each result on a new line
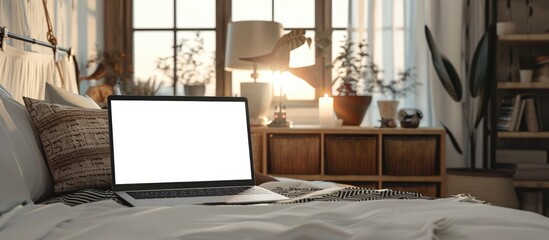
top-left (23, 97), bottom-right (111, 193)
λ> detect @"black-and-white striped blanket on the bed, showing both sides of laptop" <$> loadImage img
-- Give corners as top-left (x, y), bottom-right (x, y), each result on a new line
top-left (42, 187), bottom-right (431, 206)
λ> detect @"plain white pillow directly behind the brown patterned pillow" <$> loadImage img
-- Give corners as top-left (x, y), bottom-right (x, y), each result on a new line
top-left (0, 85), bottom-right (53, 201)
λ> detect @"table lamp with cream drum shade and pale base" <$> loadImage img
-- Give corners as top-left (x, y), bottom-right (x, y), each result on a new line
top-left (225, 21), bottom-right (284, 125)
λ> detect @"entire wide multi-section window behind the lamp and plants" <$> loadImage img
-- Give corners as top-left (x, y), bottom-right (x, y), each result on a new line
top-left (128, 0), bottom-right (404, 106)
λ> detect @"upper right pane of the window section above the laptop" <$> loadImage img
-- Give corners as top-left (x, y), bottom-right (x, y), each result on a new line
top-left (176, 0), bottom-right (215, 28)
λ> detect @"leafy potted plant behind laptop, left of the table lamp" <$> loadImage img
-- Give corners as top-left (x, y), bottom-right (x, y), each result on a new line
top-left (157, 31), bottom-right (215, 96)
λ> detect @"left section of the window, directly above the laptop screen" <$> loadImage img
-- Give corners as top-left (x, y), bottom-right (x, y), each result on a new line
top-left (132, 0), bottom-right (217, 95)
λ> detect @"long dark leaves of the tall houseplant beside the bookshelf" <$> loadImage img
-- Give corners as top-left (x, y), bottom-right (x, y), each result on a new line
top-left (425, 26), bottom-right (488, 168)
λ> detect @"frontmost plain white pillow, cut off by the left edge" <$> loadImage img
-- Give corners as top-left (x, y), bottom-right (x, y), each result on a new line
top-left (0, 128), bottom-right (30, 215)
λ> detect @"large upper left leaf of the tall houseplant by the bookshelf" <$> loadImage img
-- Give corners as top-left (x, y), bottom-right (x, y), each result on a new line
top-left (425, 26), bottom-right (462, 102)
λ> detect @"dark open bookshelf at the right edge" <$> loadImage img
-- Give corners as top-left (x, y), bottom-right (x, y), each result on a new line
top-left (490, 0), bottom-right (549, 216)
